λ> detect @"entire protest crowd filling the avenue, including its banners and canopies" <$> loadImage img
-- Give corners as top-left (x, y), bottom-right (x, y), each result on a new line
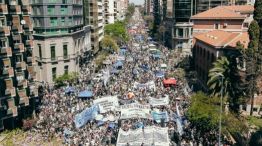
top-left (27, 10), bottom-right (194, 146)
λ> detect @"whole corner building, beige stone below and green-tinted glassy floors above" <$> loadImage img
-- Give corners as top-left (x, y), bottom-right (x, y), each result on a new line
top-left (32, 0), bottom-right (91, 83)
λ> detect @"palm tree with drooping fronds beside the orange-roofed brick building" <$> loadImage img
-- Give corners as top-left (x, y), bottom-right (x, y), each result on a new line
top-left (207, 55), bottom-right (244, 112)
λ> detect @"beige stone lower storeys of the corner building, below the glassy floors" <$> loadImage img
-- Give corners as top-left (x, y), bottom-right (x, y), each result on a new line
top-left (34, 27), bottom-right (91, 83)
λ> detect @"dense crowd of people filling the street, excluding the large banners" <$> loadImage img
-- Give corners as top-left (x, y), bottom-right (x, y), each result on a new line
top-left (25, 8), bottom-right (192, 146)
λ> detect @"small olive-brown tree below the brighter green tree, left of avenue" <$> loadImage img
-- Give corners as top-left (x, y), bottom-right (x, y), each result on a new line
top-left (101, 35), bottom-right (119, 53)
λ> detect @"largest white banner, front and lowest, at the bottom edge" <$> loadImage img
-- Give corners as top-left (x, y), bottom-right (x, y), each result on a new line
top-left (117, 126), bottom-right (169, 146)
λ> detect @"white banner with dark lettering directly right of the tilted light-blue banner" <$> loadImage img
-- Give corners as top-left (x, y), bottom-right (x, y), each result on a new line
top-left (94, 96), bottom-right (119, 113)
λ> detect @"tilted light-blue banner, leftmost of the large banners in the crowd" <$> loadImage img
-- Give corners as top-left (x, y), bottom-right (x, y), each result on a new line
top-left (74, 105), bottom-right (98, 128)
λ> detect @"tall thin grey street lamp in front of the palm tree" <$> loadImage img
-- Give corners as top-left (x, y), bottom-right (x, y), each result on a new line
top-left (217, 73), bottom-right (224, 146)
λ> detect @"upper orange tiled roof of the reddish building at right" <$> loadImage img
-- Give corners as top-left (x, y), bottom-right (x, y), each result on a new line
top-left (191, 5), bottom-right (254, 19)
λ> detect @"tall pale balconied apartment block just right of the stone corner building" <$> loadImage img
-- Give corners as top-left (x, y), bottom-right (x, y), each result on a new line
top-left (83, 0), bottom-right (105, 54)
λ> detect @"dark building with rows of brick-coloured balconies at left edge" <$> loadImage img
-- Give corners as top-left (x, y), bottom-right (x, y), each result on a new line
top-left (0, 0), bottom-right (38, 131)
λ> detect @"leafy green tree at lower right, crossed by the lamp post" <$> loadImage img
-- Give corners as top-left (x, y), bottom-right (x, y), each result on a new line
top-left (186, 92), bottom-right (248, 145)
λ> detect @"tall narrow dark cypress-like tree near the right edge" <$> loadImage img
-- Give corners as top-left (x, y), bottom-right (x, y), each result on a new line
top-left (244, 20), bottom-right (260, 115)
